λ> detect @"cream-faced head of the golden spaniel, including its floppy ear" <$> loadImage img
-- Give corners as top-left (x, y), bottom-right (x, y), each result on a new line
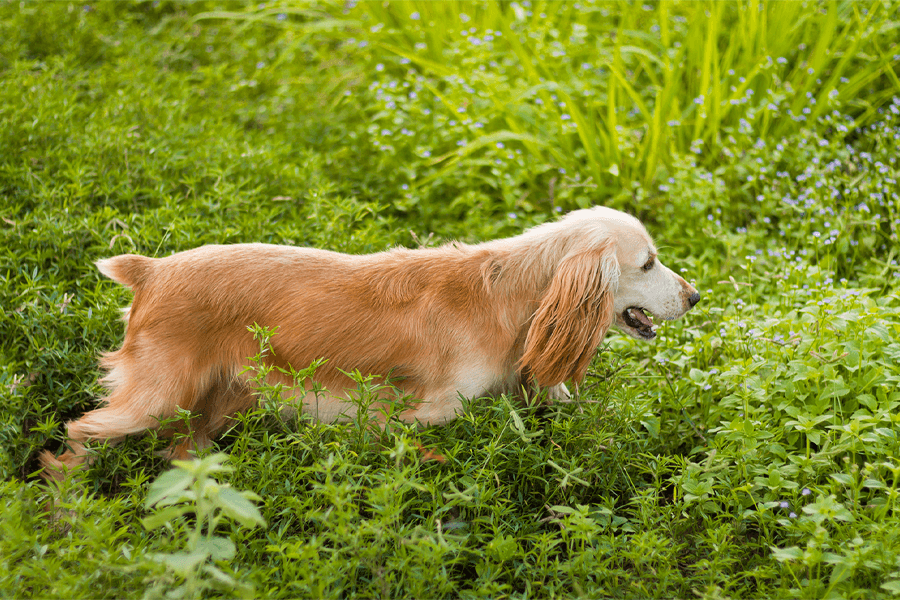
top-left (522, 207), bottom-right (700, 386)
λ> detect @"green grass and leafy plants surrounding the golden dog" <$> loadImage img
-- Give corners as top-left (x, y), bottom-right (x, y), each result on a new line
top-left (0, 1), bottom-right (900, 598)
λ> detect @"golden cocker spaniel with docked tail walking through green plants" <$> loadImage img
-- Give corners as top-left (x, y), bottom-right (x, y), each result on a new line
top-left (41, 207), bottom-right (700, 479)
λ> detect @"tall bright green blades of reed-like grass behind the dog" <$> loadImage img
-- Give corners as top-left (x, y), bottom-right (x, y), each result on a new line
top-left (348, 0), bottom-right (900, 187)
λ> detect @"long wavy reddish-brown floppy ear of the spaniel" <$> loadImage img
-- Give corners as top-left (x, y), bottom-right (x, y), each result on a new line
top-left (520, 241), bottom-right (619, 387)
